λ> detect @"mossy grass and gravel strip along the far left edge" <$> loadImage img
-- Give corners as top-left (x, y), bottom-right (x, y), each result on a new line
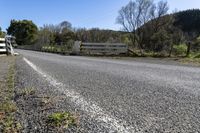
top-left (0, 57), bottom-right (21, 133)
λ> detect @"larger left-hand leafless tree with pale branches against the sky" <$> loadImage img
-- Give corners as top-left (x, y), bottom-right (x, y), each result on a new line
top-left (117, 0), bottom-right (153, 52)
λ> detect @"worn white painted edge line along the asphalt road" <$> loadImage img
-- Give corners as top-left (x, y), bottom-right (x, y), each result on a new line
top-left (23, 58), bottom-right (135, 133)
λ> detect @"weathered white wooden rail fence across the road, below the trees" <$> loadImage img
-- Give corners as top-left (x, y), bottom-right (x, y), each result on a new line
top-left (74, 42), bottom-right (128, 55)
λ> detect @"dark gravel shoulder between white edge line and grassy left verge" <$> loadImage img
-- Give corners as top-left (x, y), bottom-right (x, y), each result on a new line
top-left (15, 57), bottom-right (108, 133)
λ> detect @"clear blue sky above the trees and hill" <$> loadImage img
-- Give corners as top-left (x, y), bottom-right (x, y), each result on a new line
top-left (0, 0), bottom-right (200, 30)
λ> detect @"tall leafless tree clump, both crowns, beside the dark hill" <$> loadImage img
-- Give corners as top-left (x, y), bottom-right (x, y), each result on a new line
top-left (117, 0), bottom-right (169, 53)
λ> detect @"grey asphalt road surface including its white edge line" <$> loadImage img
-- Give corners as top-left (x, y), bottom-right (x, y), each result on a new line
top-left (17, 50), bottom-right (200, 133)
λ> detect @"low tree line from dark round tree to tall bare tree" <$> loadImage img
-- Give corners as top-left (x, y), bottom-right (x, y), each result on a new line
top-left (7, 20), bottom-right (128, 48)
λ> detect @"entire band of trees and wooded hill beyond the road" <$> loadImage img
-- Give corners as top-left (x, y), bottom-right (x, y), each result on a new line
top-left (0, 0), bottom-right (200, 56)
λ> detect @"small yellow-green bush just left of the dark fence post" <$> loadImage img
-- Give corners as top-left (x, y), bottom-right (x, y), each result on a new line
top-left (173, 44), bottom-right (187, 56)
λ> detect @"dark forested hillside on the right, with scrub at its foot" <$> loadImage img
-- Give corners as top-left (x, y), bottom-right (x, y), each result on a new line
top-left (134, 9), bottom-right (200, 55)
